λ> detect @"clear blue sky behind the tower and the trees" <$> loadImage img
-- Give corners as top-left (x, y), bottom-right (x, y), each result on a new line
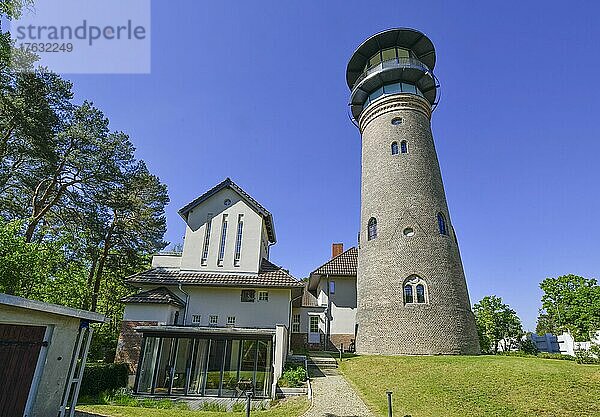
top-left (68, 0), bottom-right (600, 329)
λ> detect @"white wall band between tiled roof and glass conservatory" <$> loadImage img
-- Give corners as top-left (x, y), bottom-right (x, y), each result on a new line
top-left (180, 287), bottom-right (291, 328)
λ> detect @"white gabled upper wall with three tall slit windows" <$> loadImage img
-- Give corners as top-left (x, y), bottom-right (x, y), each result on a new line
top-left (181, 188), bottom-right (264, 273)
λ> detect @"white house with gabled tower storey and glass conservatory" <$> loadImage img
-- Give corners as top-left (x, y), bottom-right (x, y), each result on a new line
top-left (117, 178), bottom-right (303, 398)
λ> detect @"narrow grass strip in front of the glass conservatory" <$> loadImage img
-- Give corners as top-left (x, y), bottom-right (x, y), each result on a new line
top-left (77, 397), bottom-right (309, 417)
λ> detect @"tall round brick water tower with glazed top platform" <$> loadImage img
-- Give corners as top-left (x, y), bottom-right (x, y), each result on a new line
top-left (346, 29), bottom-right (479, 355)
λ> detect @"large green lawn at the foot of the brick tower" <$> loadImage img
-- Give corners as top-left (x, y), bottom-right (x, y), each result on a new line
top-left (340, 356), bottom-right (600, 417)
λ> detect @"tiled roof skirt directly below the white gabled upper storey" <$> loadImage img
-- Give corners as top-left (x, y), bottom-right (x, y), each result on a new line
top-left (127, 259), bottom-right (303, 288)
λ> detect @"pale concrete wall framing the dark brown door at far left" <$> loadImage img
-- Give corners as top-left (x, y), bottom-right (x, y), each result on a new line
top-left (0, 305), bottom-right (80, 417)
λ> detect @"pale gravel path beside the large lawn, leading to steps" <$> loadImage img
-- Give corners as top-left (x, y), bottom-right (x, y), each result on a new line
top-left (302, 369), bottom-right (375, 417)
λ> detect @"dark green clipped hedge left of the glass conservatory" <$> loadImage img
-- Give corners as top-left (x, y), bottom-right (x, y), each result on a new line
top-left (79, 363), bottom-right (129, 396)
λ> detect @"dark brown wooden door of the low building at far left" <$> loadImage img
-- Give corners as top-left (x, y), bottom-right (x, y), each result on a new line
top-left (0, 324), bottom-right (46, 416)
